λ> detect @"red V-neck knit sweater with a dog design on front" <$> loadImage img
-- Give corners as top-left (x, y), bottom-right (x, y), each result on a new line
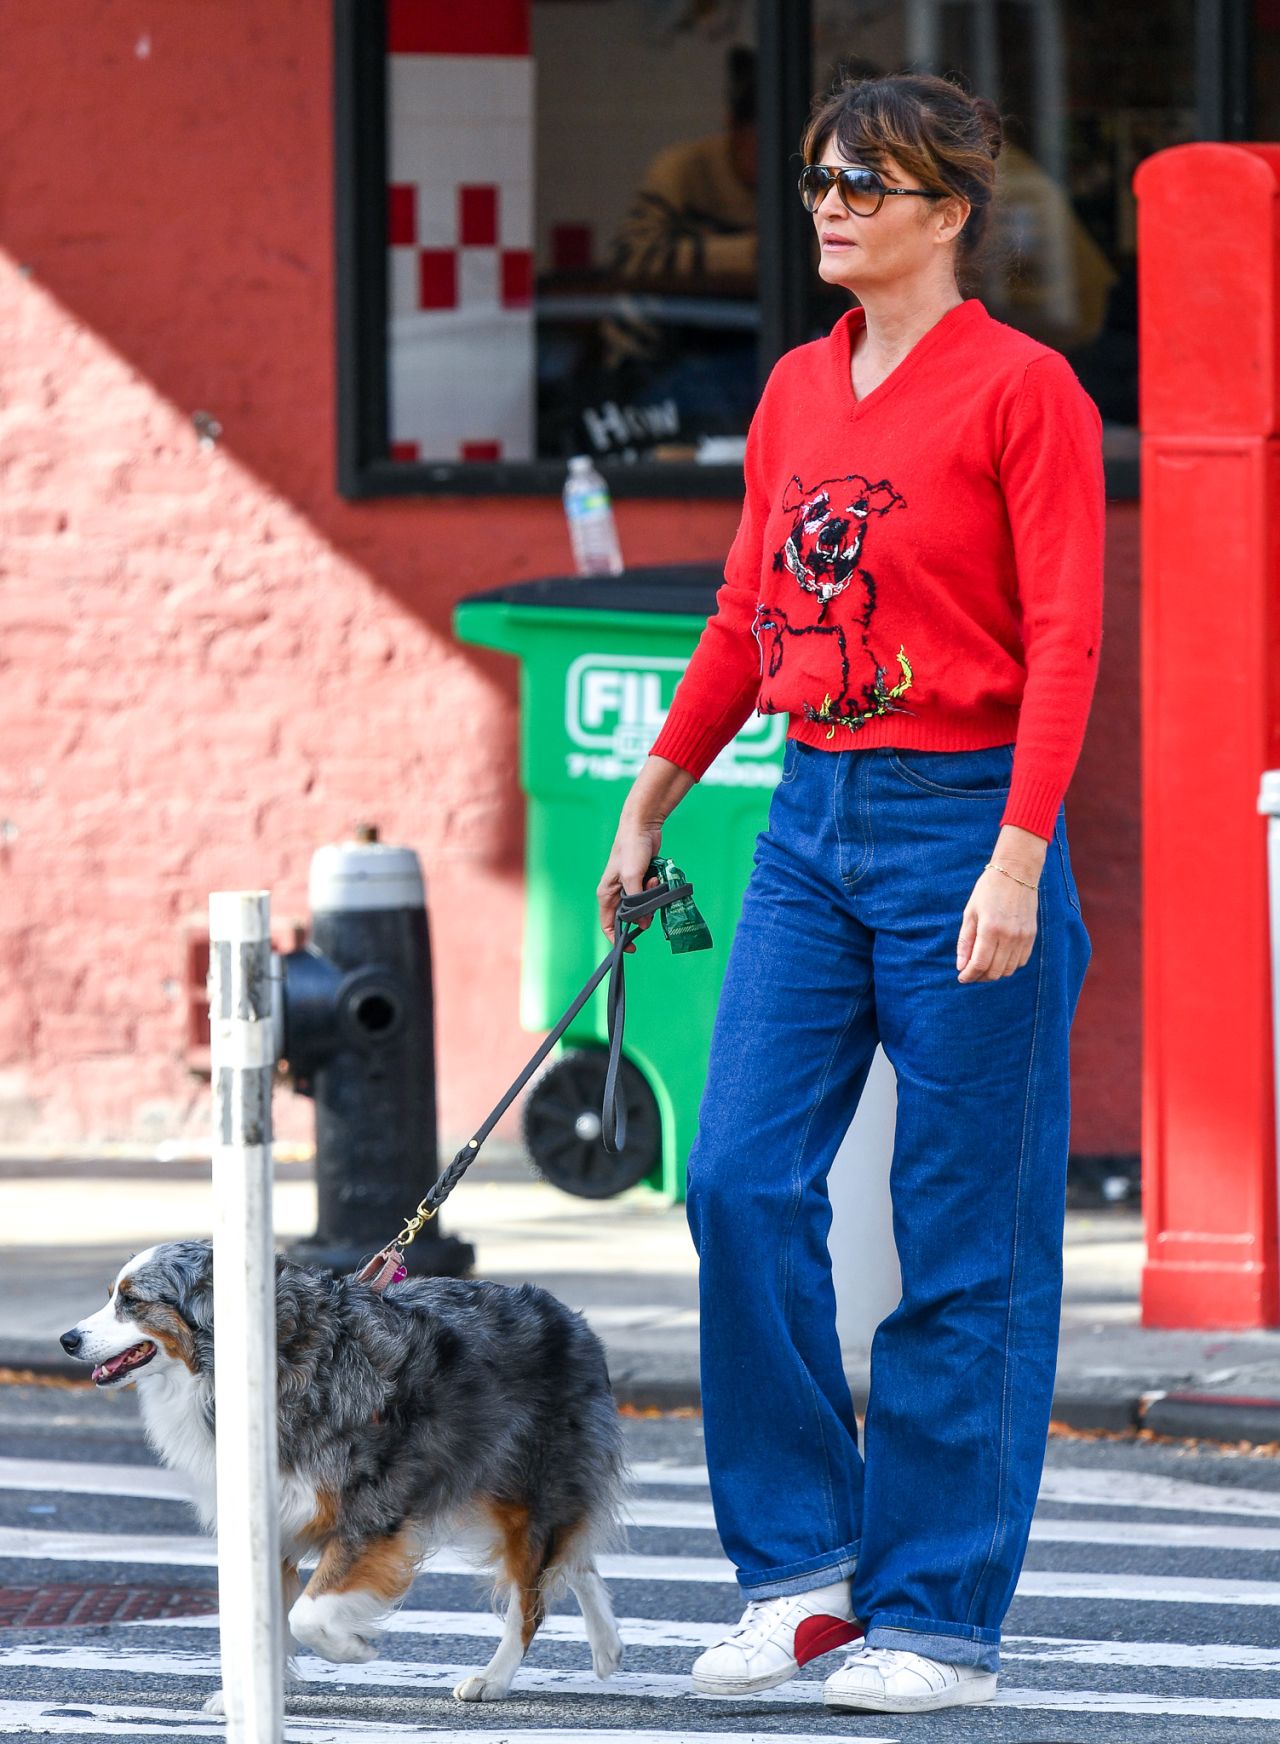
top-left (650, 296), bottom-right (1104, 839)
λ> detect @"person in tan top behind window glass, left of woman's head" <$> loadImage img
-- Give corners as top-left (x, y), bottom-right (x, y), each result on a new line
top-left (610, 47), bottom-right (757, 286)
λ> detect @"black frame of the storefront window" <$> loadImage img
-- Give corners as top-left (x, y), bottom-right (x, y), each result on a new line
top-left (333, 0), bottom-right (1254, 501)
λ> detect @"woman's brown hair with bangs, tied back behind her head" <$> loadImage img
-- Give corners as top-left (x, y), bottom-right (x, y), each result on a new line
top-left (800, 72), bottom-right (1004, 295)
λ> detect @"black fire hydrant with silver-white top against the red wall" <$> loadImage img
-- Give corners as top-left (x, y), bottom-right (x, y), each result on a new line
top-left (281, 825), bottom-right (474, 1277)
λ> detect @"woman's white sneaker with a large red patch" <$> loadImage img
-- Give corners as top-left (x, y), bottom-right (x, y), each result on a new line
top-left (692, 1580), bottom-right (861, 1695)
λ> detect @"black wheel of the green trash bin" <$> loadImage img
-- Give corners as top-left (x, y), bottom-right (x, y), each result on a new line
top-left (523, 1048), bottom-right (663, 1198)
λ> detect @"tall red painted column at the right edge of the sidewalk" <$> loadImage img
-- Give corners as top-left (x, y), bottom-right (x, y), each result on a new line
top-left (1137, 145), bottom-right (1280, 1327)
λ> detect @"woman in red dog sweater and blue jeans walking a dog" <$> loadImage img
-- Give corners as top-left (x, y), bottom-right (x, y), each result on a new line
top-left (598, 75), bottom-right (1104, 1713)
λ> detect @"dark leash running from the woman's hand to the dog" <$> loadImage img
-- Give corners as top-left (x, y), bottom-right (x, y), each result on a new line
top-left (357, 878), bottom-right (711, 1291)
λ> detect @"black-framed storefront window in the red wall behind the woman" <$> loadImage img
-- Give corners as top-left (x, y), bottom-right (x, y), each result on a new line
top-left (335, 0), bottom-right (1280, 495)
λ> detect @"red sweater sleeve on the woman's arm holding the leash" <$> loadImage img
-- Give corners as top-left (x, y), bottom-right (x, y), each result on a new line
top-left (649, 399), bottom-right (769, 781)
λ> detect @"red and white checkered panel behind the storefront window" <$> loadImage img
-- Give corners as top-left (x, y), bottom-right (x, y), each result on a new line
top-left (387, 0), bottom-right (535, 460)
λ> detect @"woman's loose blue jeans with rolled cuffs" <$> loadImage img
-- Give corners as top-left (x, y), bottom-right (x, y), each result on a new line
top-left (687, 739), bottom-right (1090, 1671)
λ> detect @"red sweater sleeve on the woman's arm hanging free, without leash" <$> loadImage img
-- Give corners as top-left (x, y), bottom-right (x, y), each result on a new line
top-left (999, 352), bottom-right (1106, 841)
